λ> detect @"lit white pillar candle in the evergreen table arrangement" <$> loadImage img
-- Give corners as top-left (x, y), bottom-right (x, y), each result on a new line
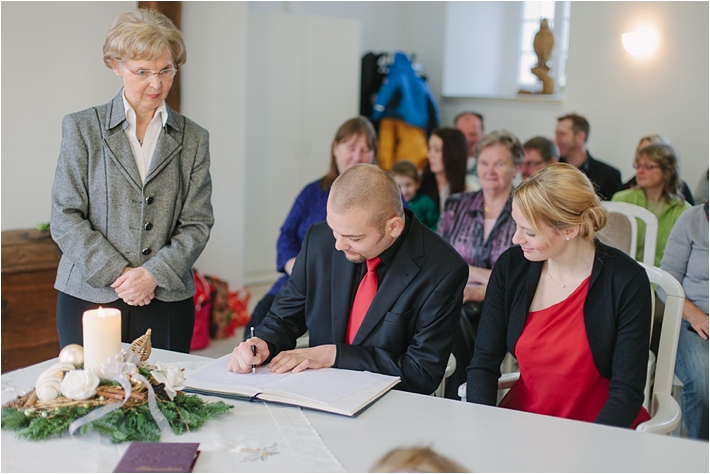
top-left (82, 308), bottom-right (121, 377)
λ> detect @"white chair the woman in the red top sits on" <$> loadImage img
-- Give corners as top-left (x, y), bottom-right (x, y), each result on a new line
top-left (458, 263), bottom-right (685, 434)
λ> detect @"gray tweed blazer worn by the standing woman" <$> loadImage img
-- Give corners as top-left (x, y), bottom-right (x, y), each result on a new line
top-left (50, 90), bottom-right (214, 303)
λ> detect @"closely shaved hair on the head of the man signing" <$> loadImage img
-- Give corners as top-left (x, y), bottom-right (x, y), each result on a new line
top-left (328, 164), bottom-right (404, 226)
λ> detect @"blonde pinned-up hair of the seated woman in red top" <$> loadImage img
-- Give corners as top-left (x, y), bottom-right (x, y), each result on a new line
top-left (513, 163), bottom-right (608, 244)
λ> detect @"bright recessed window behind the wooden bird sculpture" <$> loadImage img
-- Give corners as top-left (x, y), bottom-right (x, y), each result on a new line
top-left (442, 1), bottom-right (571, 97)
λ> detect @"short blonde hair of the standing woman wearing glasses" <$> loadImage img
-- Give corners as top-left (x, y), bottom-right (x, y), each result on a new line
top-left (104, 8), bottom-right (187, 69)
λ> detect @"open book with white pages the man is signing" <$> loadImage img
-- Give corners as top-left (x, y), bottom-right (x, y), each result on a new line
top-left (185, 354), bottom-right (400, 416)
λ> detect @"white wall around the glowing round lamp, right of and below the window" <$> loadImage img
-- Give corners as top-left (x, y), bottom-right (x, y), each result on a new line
top-left (432, 2), bottom-right (710, 183)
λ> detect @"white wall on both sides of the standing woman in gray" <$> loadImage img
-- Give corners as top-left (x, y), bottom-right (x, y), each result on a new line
top-left (1, 2), bottom-right (247, 287)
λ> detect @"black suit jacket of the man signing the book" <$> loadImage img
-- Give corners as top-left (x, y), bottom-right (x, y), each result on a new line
top-left (256, 210), bottom-right (468, 394)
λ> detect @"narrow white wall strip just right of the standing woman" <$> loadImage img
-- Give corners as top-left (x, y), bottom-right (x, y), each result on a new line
top-left (180, 2), bottom-right (247, 288)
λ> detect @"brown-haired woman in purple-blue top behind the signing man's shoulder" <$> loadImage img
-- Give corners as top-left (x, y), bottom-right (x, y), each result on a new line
top-left (244, 117), bottom-right (377, 338)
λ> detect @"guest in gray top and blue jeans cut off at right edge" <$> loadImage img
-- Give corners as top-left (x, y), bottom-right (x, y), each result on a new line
top-left (661, 201), bottom-right (709, 441)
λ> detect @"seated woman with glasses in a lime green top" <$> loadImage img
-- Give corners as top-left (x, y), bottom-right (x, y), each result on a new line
top-left (611, 143), bottom-right (691, 266)
